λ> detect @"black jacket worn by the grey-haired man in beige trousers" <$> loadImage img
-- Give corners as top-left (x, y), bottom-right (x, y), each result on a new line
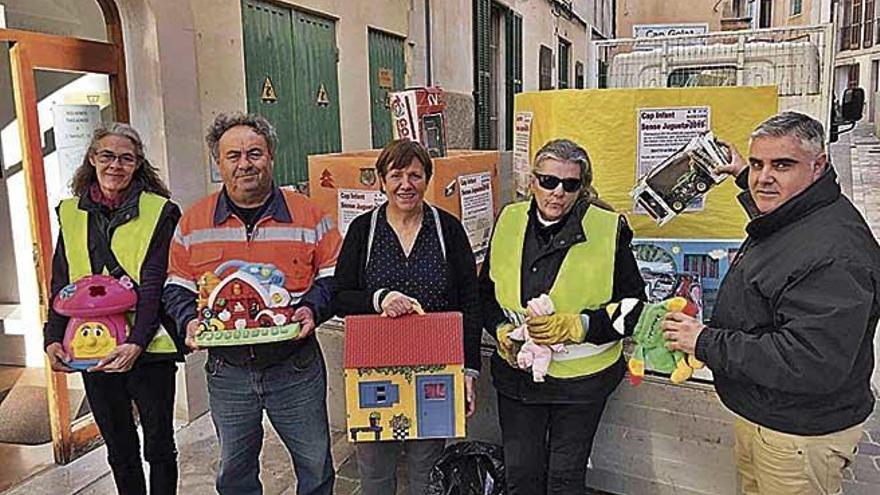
top-left (696, 169), bottom-right (880, 435)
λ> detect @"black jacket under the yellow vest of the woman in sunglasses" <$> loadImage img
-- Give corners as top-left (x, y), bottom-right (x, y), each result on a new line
top-left (480, 201), bottom-right (645, 403)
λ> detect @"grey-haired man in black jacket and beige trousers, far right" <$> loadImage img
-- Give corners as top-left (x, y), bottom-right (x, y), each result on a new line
top-left (664, 112), bottom-right (880, 495)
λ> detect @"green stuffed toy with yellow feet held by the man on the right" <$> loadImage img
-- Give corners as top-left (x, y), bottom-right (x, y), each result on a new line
top-left (627, 297), bottom-right (703, 385)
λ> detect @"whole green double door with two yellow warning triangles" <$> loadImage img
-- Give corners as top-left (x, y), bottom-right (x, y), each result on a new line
top-left (242, 0), bottom-right (342, 185)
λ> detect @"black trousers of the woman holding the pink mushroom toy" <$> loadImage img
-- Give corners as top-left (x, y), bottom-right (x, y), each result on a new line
top-left (83, 361), bottom-right (177, 495)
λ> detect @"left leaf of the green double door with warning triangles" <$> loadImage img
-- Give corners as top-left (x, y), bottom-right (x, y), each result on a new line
top-left (239, 0), bottom-right (298, 184)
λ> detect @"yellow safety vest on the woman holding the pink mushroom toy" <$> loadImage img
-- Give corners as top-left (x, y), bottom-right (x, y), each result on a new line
top-left (58, 192), bottom-right (177, 354)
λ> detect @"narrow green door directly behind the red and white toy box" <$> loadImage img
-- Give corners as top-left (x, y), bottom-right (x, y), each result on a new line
top-left (367, 29), bottom-right (406, 148)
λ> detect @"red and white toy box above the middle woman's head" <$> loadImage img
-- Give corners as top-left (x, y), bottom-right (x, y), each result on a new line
top-left (388, 88), bottom-right (446, 158)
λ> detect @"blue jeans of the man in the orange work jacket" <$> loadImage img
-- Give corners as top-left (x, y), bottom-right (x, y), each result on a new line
top-left (205, 346), bottom-right (335, 495)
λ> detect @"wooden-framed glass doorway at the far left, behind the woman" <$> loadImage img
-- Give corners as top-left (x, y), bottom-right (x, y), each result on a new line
top-left (0, 0), bottom-right (128, 491)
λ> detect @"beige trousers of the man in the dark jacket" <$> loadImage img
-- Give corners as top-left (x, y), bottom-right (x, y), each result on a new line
top-left (734, 417), bottom-right (862, 495)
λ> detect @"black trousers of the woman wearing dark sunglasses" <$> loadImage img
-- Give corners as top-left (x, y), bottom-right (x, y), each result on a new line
top-left (498, 394), bottom-right (605, 495)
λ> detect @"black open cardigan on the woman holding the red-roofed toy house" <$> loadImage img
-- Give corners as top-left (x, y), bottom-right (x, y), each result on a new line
top-left (333, 204), bottom-right (483, 371)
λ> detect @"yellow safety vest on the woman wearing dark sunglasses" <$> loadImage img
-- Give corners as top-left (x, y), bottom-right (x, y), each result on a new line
top-left (489, 201), bottom-right (623, 378)
